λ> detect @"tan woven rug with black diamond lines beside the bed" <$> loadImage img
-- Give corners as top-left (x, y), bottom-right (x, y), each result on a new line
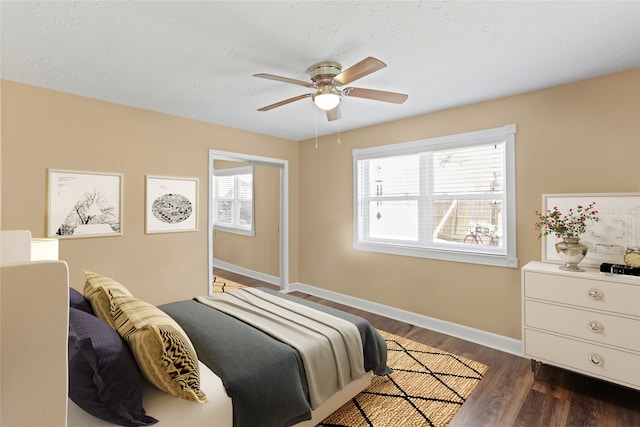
top-left (318, 331), bottom-right (488, 427)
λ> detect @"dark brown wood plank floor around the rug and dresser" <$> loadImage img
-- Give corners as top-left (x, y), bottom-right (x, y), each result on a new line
top-left (215, 269), bottom-right (640, 427)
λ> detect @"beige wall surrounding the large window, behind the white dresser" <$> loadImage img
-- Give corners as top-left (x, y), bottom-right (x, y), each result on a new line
top-left (299, 69), bottom-right (640, 338)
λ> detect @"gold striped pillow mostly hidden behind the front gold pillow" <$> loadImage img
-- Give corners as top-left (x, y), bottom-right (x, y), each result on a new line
top-left (82, 270), bottom-right (132, 327)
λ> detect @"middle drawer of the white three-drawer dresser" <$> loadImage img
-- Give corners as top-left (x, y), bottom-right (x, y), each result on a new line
top-left (524, 300), bottom-right (640, 351)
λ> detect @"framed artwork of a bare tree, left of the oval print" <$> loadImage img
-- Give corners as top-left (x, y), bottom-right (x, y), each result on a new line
top-left (47, 169), bottom-right (122, 238)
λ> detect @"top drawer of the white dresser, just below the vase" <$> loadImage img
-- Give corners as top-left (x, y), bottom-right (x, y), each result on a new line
top-left (523, 271), bottom-right (640, 316)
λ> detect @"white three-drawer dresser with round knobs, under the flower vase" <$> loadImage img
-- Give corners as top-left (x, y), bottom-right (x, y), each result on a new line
top-left (522, 262), bottom-right (640, 389)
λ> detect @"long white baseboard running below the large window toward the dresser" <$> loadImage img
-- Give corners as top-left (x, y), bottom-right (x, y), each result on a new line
top-left (289, 283), bottom-right (522, 356)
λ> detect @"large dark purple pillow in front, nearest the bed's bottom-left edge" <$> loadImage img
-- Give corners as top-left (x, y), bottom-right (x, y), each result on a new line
top-left (69, 307), bottom-right (158, 426)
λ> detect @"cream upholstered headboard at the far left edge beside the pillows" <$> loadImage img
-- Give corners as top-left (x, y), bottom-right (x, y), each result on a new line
top-left (0, 231), bottom-right (69, 427)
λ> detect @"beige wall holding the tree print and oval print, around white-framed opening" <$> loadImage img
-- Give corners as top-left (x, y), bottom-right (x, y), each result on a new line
top-left (1, 80), bottom-right (298, 304)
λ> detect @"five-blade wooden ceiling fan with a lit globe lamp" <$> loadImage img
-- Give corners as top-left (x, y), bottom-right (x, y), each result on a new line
top-left (254, 56), bottom-right (409, 121)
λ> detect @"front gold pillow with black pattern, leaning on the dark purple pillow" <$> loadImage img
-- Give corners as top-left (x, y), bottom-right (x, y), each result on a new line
top-left (112, 296), bottom-right (207, 403)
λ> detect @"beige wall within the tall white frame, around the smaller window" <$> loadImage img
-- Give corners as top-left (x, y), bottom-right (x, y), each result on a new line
top-left (213, 160), bottom-right (280, 277)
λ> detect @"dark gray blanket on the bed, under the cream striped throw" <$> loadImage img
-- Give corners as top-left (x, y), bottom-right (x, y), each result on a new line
top-left (160, 289), bottom-right (390, 427)
